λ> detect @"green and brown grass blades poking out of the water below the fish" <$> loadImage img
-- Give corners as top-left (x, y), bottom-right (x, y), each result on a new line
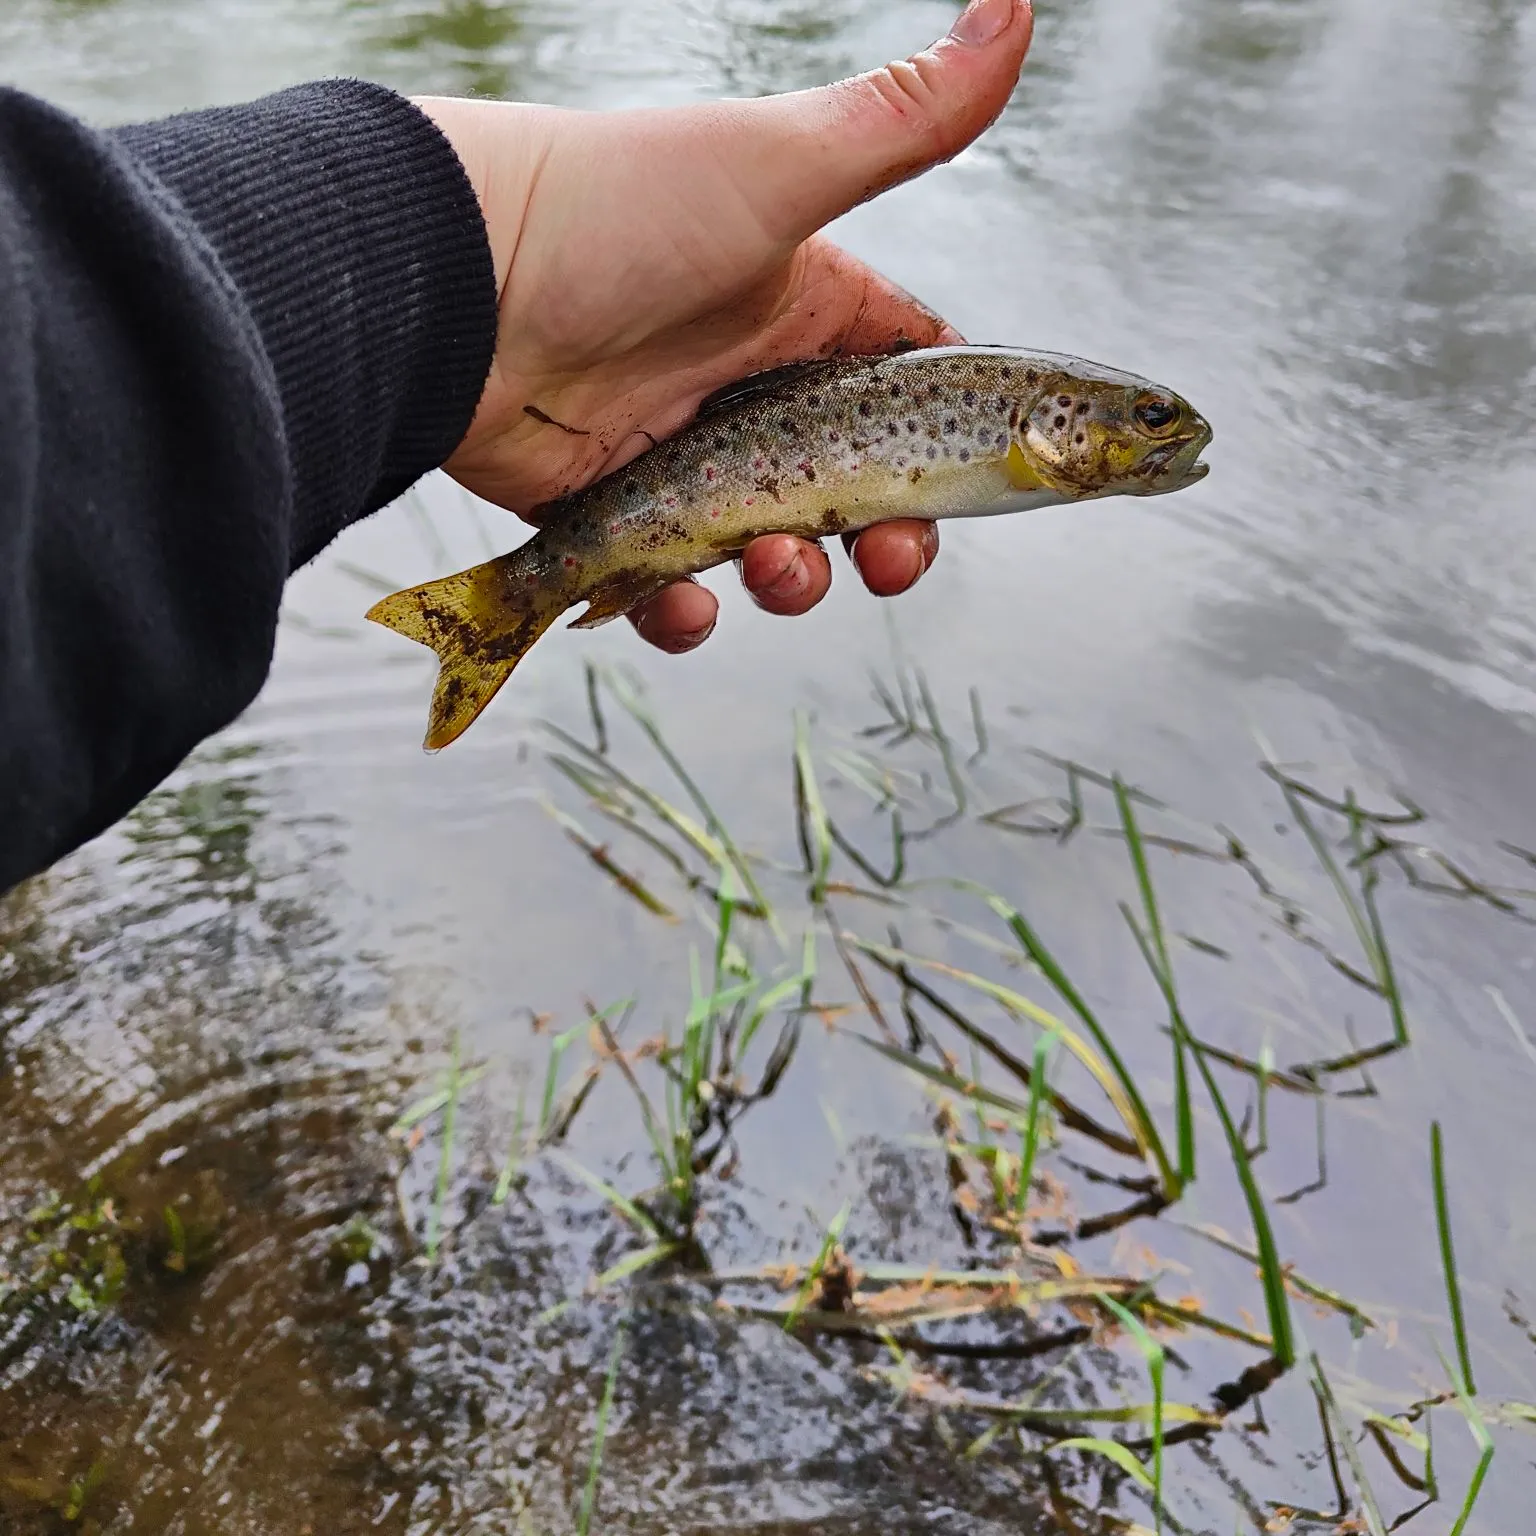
top-left (380, 645), bottom-right (1518, 1536)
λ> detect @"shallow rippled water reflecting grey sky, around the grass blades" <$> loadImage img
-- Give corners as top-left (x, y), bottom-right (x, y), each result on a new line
top-left (0, 0), bottom-right (1536, 1533)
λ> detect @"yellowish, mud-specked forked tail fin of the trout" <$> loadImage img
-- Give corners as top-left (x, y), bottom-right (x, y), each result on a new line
top-left (367, 550), bottom-right (568, 751)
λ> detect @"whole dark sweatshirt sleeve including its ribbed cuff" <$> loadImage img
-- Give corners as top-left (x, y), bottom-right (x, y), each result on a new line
top-left (0, 81), bottom-right (496, 891)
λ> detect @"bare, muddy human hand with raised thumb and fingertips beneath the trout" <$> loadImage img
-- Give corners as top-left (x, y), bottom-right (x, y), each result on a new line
top-left (418, 0), bottom-right (1032, 651)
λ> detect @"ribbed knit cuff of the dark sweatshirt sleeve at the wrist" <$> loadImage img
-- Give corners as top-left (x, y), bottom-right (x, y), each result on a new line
top-left (114, 80), bottom-right (496, 567)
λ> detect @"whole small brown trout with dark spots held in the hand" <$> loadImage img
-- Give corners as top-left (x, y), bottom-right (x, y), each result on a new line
top-left (367, 347), bottom-right (1210, 751)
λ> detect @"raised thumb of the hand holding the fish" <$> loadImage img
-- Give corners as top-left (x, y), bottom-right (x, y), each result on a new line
top-left (722, 0), bottom-right (1034, 244)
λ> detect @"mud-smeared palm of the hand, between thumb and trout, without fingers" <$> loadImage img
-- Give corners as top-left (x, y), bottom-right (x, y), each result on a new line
top-left (447, 108), bottom-right (958, 515)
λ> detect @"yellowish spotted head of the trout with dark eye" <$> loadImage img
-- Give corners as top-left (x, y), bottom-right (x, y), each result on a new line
top-left (1017, 366), bottom-right (1212, 501)
